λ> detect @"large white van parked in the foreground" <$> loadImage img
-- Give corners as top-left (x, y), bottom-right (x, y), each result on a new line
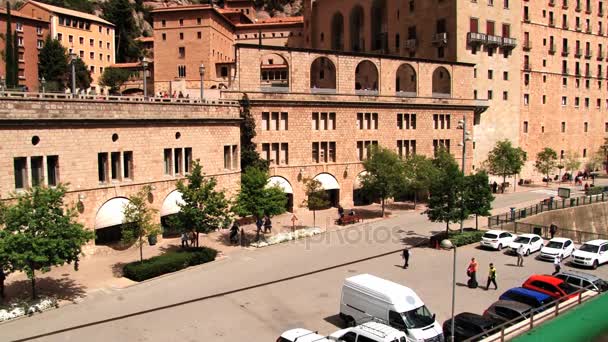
top-left (340, 274), bottom-right (443, 342)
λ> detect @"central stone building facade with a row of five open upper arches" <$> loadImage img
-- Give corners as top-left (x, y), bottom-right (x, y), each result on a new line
top-left (222, 44), bottom-right (486, 206)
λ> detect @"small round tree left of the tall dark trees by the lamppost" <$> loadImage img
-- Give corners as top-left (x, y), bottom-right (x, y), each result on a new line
top-left (404, 154), bottom-right (437, 210)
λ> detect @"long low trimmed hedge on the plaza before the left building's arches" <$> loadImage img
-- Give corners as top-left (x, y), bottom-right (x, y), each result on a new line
top-left (123, 247), bottom-right (217, 281)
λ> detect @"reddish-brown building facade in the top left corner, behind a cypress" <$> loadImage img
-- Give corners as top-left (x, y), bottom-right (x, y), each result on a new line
top-left (0, 8), bottom-right (49, 91)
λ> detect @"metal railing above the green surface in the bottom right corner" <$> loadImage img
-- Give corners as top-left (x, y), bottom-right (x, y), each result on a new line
top-left (465, 285), bottom-right (605, 342)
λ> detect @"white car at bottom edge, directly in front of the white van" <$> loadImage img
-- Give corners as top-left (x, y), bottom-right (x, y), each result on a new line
top-left (330, 322), bottom-right (407, 342)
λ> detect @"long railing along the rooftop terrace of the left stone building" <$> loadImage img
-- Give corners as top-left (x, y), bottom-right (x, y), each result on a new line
top-left (0, 91), bottom-right (239, 105)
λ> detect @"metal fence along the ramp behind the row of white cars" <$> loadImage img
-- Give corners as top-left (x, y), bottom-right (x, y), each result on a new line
top-left (488, 193), bottom-right (608, 228)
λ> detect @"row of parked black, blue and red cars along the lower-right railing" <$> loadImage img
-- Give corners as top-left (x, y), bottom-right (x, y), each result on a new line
top-left (443, 271), bottom-right (608, 341)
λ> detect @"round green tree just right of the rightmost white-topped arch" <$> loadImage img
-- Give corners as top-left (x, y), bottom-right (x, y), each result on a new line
top-left (361, 147), bottom-right (405, 217)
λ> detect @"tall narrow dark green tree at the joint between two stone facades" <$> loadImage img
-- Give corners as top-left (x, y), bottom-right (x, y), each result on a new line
top-left (241, 94), bottom-right (268, 171)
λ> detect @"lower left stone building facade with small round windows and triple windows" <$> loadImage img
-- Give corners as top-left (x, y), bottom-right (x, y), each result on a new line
top-left (0, 97), bottom-right (240, 243)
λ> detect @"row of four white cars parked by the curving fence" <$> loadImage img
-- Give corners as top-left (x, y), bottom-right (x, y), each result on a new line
top-left (480, 230), bottom-right (608, 269)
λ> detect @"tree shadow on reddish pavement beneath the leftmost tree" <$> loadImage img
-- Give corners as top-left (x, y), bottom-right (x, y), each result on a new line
top-left (5, 277), bottom-right (86, 302)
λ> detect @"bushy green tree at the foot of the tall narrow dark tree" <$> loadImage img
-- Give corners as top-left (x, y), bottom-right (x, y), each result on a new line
top-left (232, 167), bottom-right (287, 218)
